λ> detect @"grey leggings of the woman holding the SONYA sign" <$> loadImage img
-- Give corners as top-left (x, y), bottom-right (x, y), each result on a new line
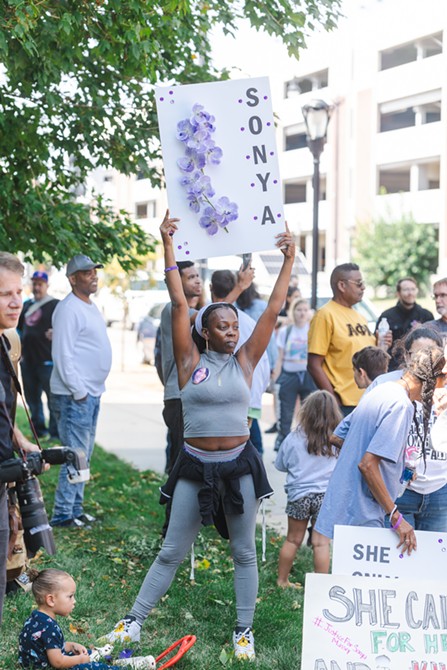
top-left (129, 475), bottom-right (258, 627)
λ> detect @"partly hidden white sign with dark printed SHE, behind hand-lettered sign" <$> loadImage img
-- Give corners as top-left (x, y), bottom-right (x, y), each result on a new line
top-left (332, 526), bottom-right (447, 579)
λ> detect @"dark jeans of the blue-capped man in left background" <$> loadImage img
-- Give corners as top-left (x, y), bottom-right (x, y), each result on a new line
top-left (21, 361), bottom-right (58, 438)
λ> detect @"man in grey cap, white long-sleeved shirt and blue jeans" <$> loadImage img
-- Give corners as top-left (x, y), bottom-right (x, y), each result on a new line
top-left (50, 254), bottom-right (112, 528)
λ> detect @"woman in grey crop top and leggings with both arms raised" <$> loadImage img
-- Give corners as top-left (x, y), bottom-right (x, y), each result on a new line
top-left (103, 211), bottom-right (295, 659)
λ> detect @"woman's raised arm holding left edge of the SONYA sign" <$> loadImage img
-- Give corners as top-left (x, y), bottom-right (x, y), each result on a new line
top-left (160, 210), bottom-right (200, 388)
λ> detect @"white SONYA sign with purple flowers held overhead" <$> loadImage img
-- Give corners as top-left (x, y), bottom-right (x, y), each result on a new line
top-left (155, 77), bottom-right (285, 260)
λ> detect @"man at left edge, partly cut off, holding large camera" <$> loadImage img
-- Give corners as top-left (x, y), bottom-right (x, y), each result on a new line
top-left (0, 252), bottom-right (39, 622)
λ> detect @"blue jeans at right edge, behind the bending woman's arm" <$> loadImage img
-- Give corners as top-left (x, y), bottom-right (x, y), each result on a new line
top-left (386, 484), bottom-right (447, 533)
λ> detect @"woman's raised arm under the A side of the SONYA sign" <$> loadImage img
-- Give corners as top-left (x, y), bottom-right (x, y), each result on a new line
top-left (237, 228), bottom-right (295, 375)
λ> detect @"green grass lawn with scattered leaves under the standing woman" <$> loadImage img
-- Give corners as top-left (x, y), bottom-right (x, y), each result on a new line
top-left (0, 412), bottom-right (312, 670)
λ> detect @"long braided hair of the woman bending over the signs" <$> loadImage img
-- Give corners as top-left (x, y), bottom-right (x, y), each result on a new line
top-left (404, 346), bottom-right (445, 464)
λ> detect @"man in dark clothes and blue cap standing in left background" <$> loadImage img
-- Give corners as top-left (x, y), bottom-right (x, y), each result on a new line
top-left (18, 270), bottom-right (59, 438)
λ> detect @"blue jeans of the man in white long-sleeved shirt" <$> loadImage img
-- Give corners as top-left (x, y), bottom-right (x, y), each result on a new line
top-left (51, 394), bottom-right (101, 524)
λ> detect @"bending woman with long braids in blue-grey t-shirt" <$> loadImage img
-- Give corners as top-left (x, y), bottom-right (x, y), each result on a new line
top-left (313, 346), bottom-right (445, 554)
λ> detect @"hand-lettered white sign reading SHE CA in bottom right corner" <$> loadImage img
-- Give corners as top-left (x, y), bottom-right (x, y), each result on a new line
top-left (301, 574), bottom-right (447, 670)
